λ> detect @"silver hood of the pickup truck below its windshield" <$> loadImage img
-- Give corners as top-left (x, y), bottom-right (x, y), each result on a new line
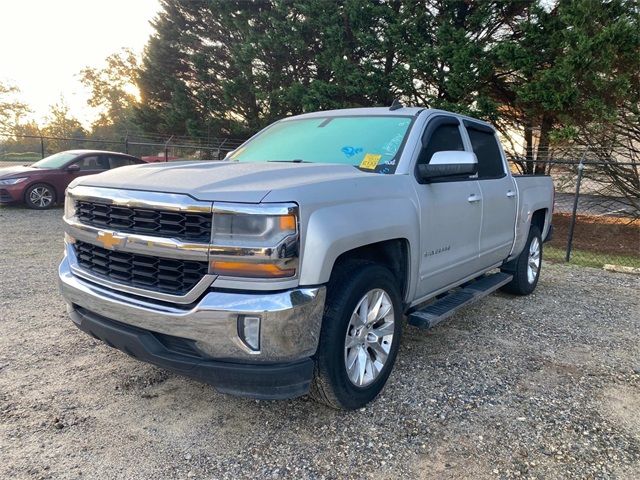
top-left (75, 161), bottom-right (375, 203)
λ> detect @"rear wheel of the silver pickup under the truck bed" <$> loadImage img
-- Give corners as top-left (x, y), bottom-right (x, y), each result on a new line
top-left (501, 225), bottom-right (542, 295)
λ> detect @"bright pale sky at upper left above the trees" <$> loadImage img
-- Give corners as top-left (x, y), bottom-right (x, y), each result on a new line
top-left (0, 0), bottom-right (160, 126)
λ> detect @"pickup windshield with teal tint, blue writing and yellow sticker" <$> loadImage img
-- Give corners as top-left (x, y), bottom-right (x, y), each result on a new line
top-left (229, 115), bottom-right (412, 173)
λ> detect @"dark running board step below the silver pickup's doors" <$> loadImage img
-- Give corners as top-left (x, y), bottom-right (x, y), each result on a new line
top-left (408, 273), bottom-right (513, 329)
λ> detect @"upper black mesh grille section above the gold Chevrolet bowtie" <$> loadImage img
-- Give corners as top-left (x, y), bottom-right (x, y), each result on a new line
top-left (76, 200), bottom-right (211, 243)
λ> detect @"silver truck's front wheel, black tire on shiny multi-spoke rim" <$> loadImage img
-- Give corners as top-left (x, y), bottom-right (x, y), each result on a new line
top-left (310, 261), bottom-right (402, 410)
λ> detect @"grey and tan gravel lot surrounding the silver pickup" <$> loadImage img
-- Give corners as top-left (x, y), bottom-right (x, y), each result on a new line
top-left (0, 208), bottom-right (640, 479)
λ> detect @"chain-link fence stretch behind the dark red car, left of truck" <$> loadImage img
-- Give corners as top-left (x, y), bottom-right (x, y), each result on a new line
top-left (0, 134), bottom-right (243, 166)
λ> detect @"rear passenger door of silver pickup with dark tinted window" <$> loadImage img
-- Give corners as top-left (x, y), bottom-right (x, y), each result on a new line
top-left (463, 120), bottom-right (518, 268)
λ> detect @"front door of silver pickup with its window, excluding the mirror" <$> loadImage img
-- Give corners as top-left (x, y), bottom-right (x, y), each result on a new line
top-left (415, 115), bottom-right (482, 298)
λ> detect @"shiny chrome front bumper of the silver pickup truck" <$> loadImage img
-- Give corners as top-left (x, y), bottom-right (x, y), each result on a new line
top-left (58, 251), bottom-right (325, 363)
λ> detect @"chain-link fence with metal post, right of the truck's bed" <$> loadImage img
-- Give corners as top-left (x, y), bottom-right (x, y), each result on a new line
top-left (513, 157), bottom-right (640, 272)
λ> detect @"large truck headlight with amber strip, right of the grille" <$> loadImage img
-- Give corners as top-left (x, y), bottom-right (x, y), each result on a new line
top-left (210, 203), bottom-right (299, 278)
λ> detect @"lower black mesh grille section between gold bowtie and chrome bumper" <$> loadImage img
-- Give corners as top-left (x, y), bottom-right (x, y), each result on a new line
top-left (74, 241), bottom-right (208, 295)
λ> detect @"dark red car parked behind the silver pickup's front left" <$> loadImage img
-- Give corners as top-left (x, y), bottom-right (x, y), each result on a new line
top-left (0, 150), bottom-right (145, 210)
